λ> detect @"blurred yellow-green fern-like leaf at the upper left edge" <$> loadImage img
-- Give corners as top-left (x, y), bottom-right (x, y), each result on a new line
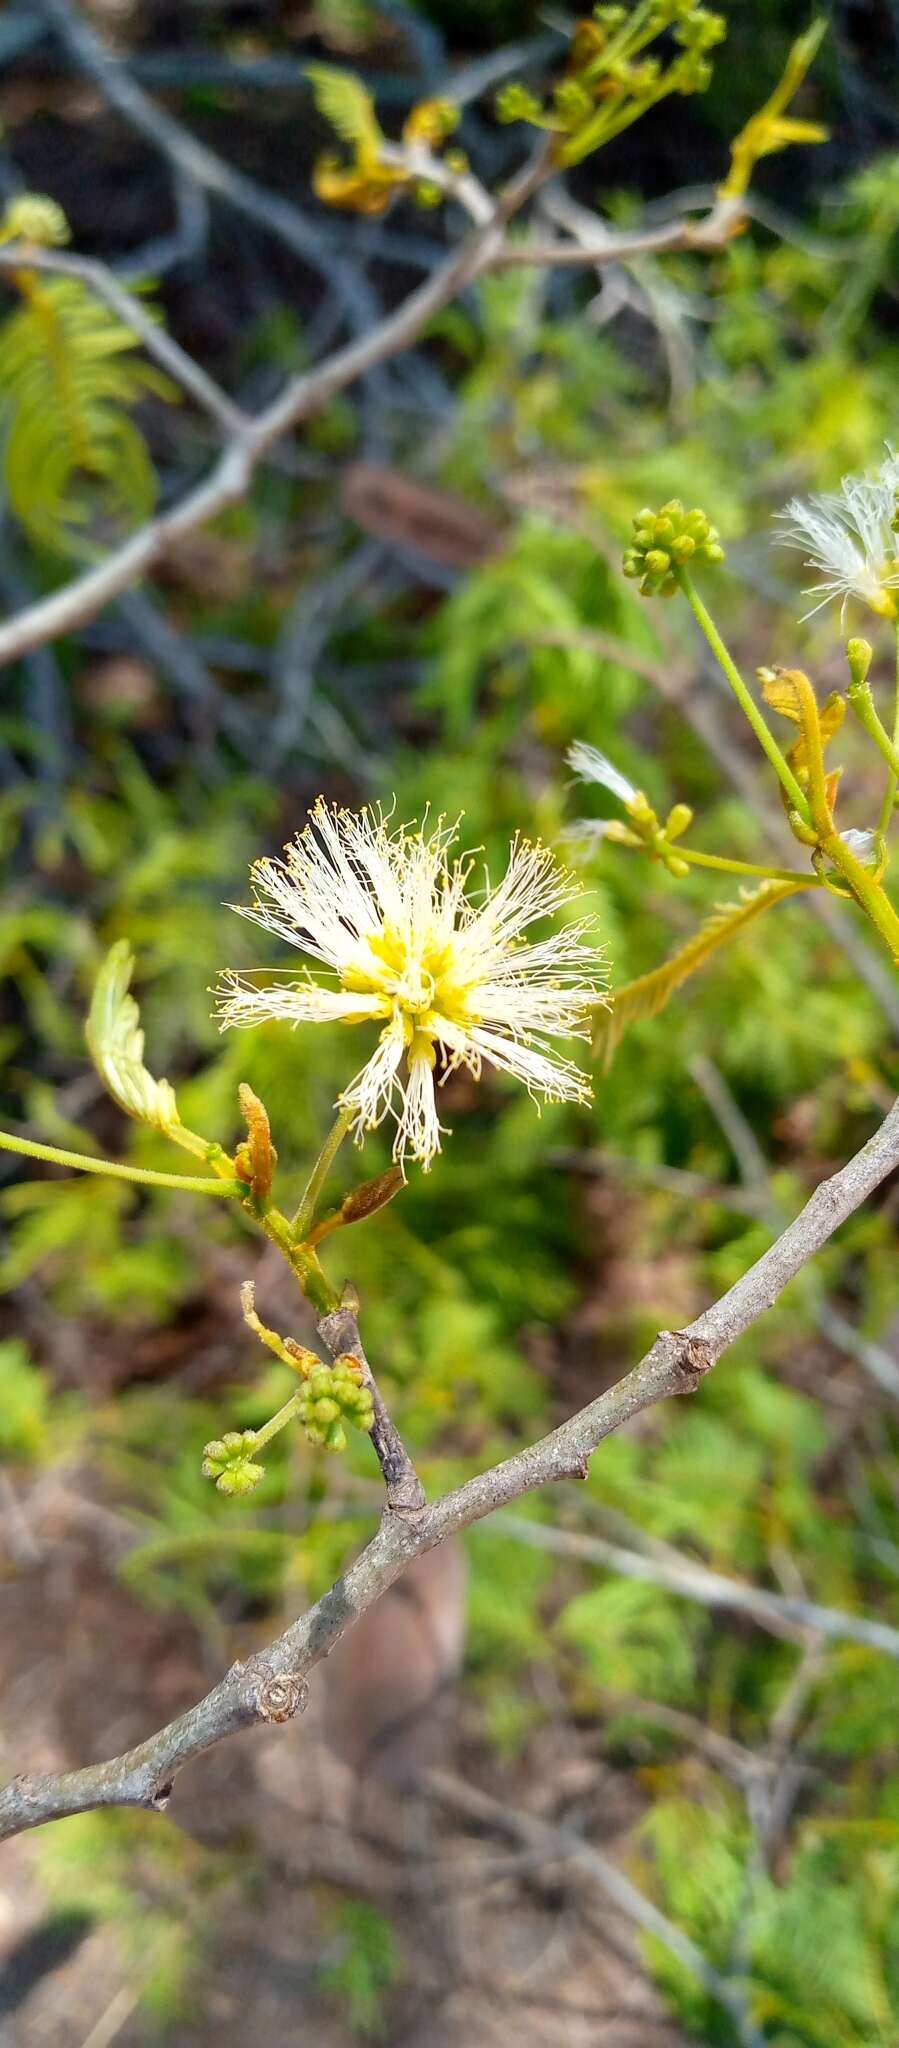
top-left (0, 276), bottom-right (178, 555)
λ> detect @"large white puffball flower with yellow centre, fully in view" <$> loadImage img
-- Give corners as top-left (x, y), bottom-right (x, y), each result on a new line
top-left (217, 799), bottom-right (608, 1167)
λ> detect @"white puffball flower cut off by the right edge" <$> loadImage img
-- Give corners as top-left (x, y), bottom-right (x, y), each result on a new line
top-left (776, 449), bottom-right (899, 618)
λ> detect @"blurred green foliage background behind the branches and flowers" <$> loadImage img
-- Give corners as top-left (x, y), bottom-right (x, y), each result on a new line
top-left (0, 0), bottom-right (899, 2048)
